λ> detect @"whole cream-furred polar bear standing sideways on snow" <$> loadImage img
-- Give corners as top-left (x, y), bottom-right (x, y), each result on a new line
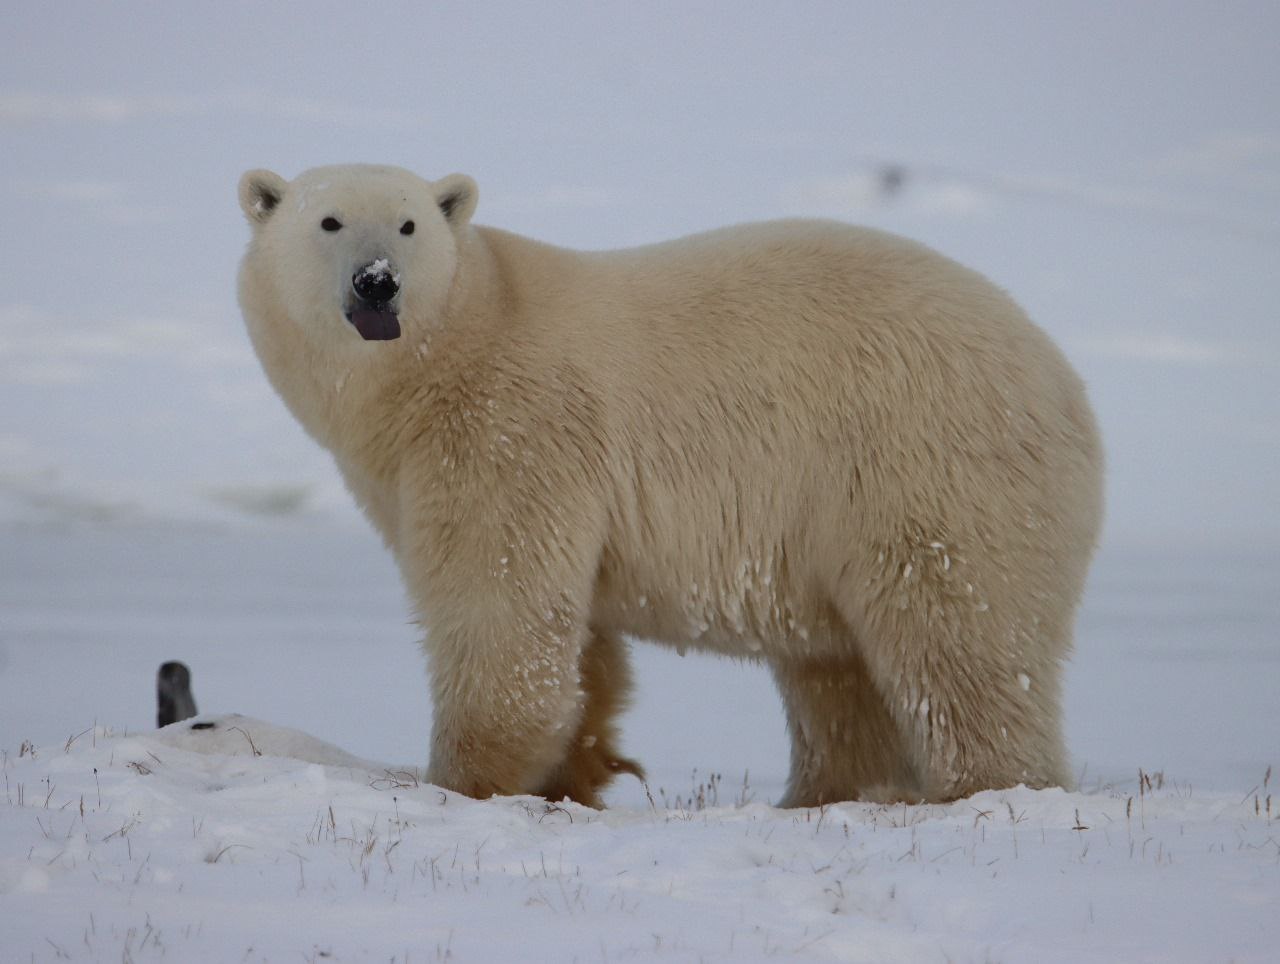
top-left (239, 165), bottom-right (1102, 807)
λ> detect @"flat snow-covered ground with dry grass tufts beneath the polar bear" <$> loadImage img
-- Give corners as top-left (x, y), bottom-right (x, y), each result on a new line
top-left (0, 524), bottom-right (1280, 961)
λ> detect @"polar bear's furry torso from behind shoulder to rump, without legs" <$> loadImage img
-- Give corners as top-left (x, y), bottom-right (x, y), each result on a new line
top-left (460, 220), bottom-right (1102, 654)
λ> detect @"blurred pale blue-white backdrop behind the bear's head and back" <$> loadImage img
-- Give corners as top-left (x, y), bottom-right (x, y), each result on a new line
top-left (0, 0), bottom-right (1280, 540)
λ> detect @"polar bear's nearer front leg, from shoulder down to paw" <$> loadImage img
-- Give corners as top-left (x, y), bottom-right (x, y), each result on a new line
top-left (394, 368), bottom-right (619, 798)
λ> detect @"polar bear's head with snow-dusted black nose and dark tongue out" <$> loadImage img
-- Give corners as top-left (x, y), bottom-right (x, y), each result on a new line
top-left (239, 164), bottom-right (477, 346)
